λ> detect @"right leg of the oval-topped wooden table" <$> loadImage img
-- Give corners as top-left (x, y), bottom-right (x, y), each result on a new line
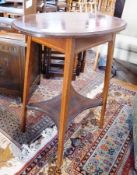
top-left (100, 34), bottom-right (115, 128)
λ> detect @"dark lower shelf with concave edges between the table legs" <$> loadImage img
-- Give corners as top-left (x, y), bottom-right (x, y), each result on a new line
top-left (27, 86), bottom-right (102, 127)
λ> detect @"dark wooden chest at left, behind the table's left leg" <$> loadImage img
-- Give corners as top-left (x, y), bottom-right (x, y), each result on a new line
top-left (0, 33), bottom-right (40, 97)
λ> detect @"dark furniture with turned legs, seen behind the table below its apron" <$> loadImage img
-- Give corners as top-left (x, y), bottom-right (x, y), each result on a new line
top-left (42, 47), bottom-right (86, 80)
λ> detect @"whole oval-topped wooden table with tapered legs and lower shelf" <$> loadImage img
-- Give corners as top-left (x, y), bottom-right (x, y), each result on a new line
top-left (13, 12), bottom-right (126, 168)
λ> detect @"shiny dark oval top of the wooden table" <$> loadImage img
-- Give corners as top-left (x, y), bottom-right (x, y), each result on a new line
top-left (12, 12), bottom-right (126, 38)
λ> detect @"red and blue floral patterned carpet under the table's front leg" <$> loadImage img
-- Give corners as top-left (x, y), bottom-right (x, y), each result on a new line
top-left (27, 80), bottom-right (135, 175)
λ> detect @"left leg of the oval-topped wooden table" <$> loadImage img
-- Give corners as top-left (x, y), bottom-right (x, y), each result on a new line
top-left (21, 36), bottom-right (32, 132)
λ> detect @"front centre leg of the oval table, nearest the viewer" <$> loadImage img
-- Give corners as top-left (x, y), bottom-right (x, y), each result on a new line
top-left (57, 39), bottom-right (75, 168)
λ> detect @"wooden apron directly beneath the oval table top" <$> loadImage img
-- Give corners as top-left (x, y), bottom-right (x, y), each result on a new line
top-left (32, 33), bottom-right (113, 54)
